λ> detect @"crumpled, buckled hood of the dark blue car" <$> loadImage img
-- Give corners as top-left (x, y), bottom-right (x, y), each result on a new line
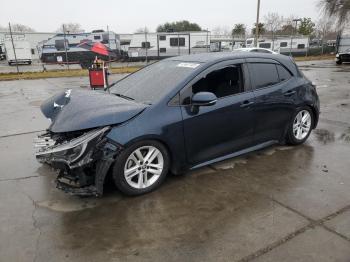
top-left (41, 89), bottom-right (147, 133)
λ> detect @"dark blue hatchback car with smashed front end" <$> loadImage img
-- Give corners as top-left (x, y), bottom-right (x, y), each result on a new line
top-left (36, 52), bottom-right (320, 196)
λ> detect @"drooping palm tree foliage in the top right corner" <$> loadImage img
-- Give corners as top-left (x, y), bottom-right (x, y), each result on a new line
top-left (320, 0), bottom-right (350, 25)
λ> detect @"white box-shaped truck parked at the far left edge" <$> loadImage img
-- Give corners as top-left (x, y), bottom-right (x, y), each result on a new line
top-left (5, 40), bottom-right (32, 65)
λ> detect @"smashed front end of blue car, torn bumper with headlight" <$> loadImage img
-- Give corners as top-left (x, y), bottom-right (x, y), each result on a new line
top-left (34, 127), bottom-right (122, 196)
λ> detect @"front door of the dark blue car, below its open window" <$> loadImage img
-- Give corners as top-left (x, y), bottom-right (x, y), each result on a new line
top-left (180, 59), bottom-right (254, 164)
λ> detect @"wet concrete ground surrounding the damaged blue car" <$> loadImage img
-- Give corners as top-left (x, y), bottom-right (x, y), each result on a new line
top-left (0, 61), bottom-right (350, 261)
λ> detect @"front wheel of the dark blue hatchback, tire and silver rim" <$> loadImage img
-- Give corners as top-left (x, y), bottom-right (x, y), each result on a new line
top-left (113, 140), bottom-right (170, 196)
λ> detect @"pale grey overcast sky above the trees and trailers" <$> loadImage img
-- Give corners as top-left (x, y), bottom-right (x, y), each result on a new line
top-left (0, 0), bottom-right (320, 33)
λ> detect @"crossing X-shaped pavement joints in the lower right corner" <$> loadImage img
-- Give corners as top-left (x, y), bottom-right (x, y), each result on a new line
top-left (238, 200), bottom-right (350, 262)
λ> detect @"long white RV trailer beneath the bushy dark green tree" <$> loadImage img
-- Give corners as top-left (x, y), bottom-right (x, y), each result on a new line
top-left (128, 31), bottom-right (210, 60)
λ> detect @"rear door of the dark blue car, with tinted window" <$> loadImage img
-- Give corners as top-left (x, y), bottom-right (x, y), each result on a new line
top-left (247, 58), bottom-right (296, 144)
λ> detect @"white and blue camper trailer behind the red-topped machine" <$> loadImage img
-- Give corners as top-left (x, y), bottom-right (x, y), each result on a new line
top-left (39, 30), bottom-right (121, 68)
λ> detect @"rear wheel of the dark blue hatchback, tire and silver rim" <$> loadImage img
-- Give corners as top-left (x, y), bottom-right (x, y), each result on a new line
top-left (286, 107), bottom-right (315, 145)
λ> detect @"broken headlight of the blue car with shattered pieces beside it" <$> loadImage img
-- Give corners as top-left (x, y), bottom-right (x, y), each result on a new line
top-left (35, 127), bottom-right (109, 166)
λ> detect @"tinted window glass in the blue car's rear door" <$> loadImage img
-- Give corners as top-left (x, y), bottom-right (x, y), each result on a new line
top-left (249, 63), bottom-right (279, 89)
